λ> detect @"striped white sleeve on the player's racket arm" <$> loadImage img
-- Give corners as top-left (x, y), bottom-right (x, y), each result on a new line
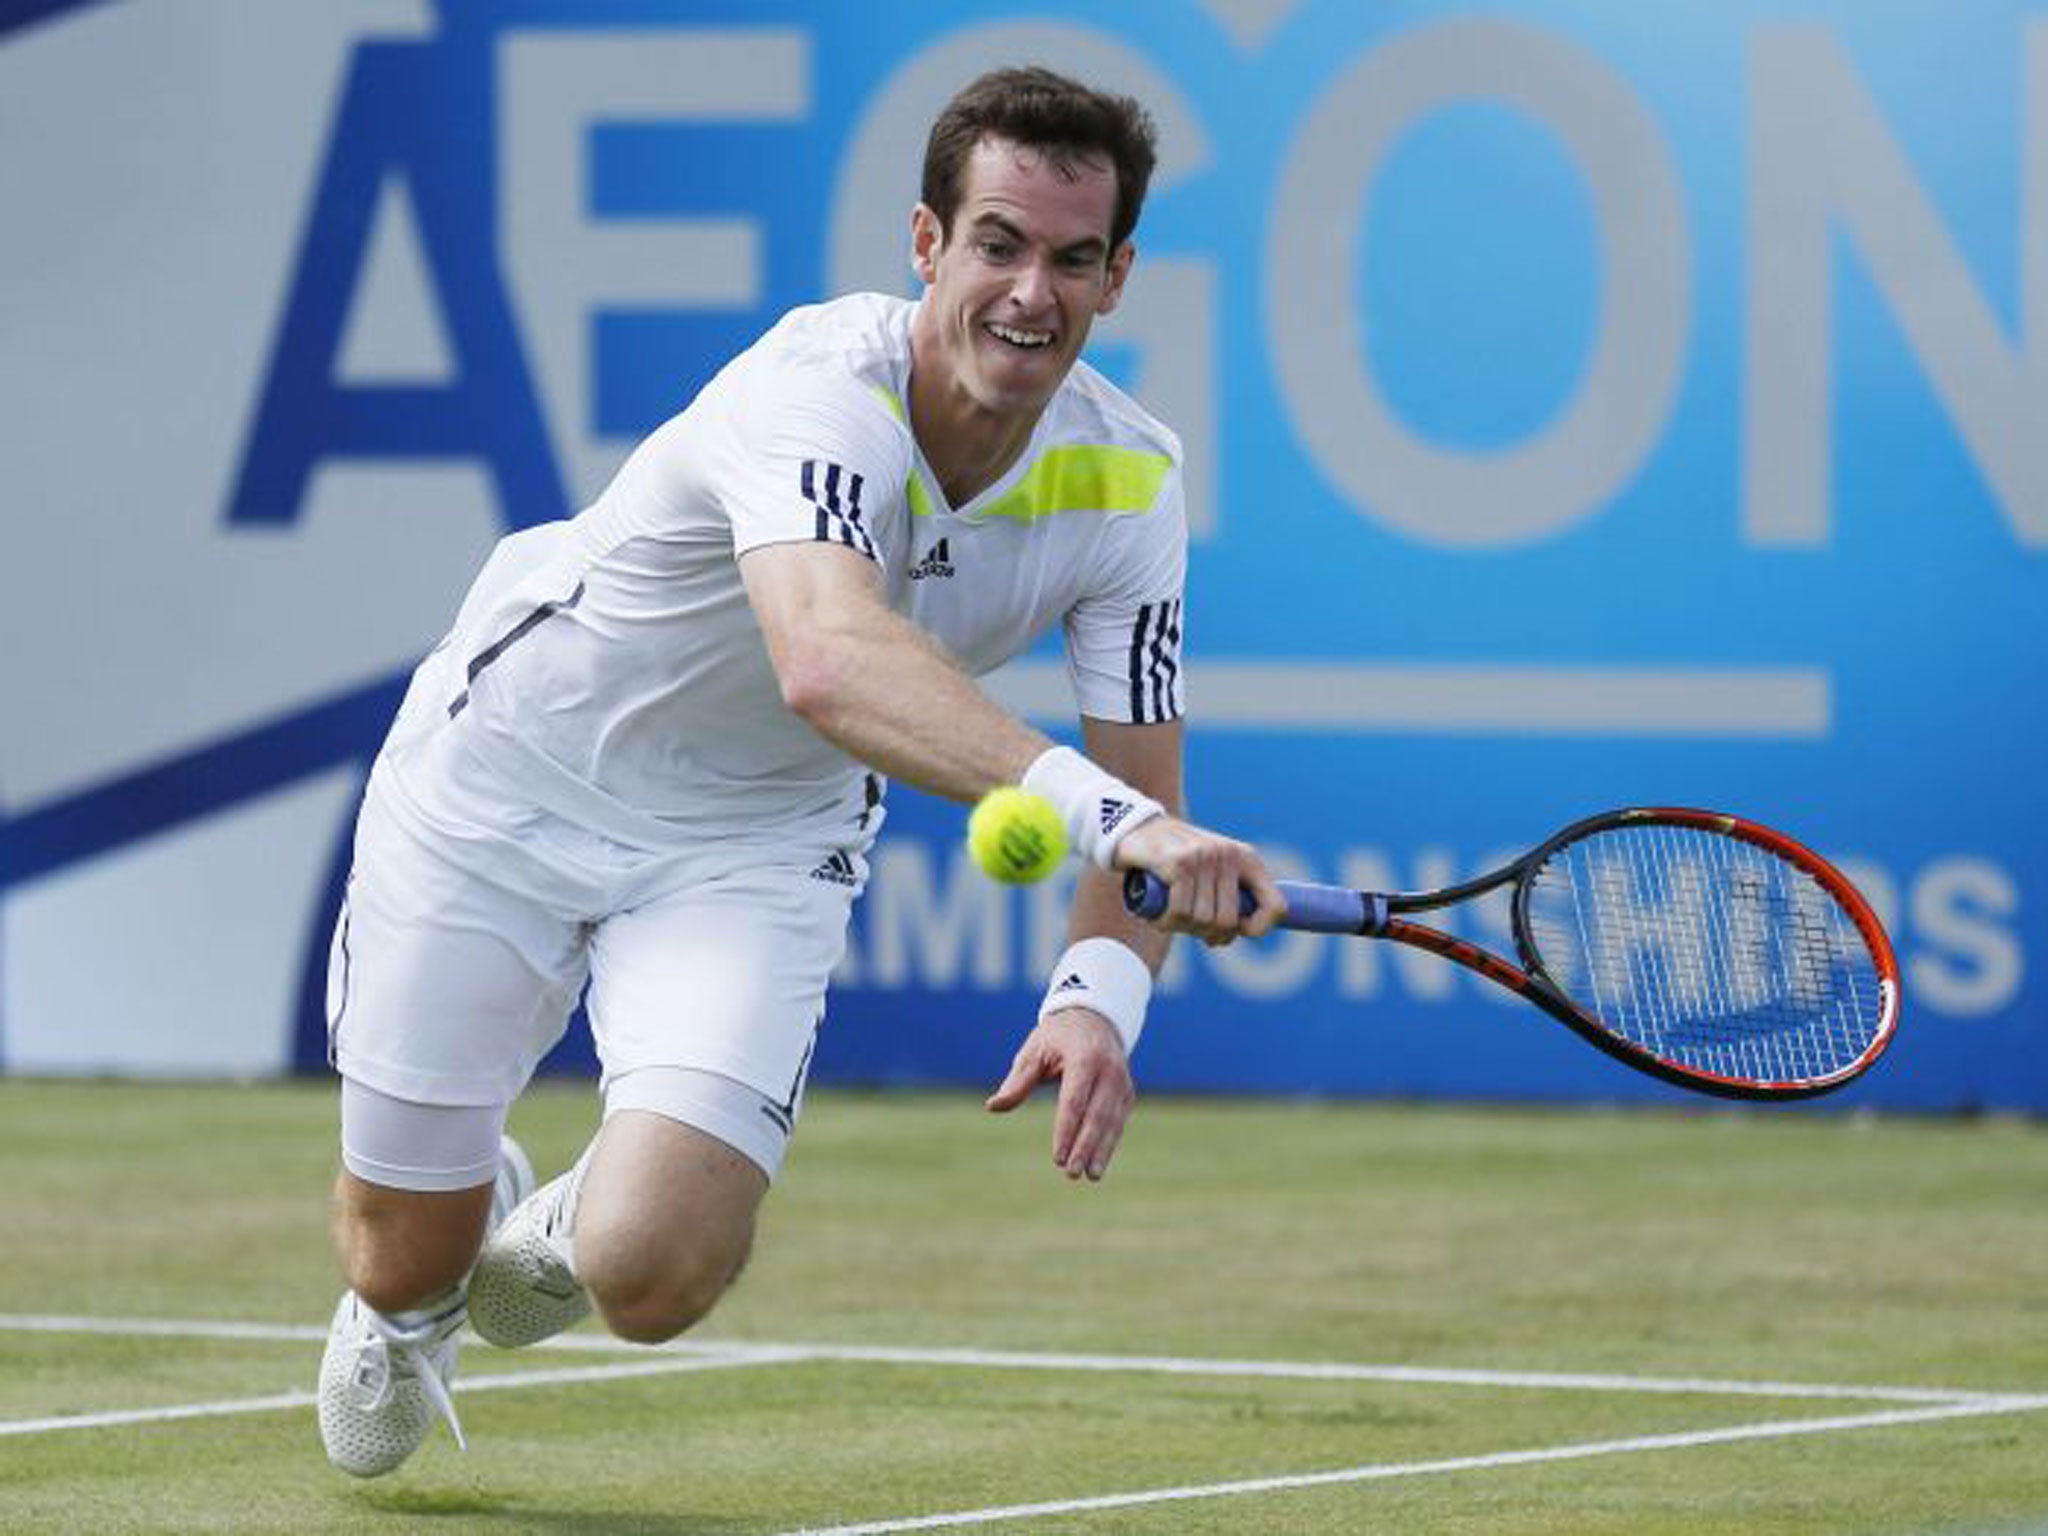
top-left (719, 365), bottom-right (911, 561)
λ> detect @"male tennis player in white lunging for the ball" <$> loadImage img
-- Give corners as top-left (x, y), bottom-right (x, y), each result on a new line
top-left (319, 70), bottom-right (1280, 1477)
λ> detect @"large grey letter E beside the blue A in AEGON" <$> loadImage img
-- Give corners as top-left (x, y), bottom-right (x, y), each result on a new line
top-left (498, 27), bottom-right (811, 506)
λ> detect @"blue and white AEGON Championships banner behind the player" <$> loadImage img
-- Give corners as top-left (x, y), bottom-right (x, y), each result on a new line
top-left (0, 0), bottom-right (2048, 1110)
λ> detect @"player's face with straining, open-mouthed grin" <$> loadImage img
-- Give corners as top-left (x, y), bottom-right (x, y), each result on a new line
top-left (911, 139), bottom-right (1133, 416)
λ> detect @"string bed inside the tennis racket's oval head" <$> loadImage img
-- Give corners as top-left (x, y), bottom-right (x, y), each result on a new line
top-left (1528, 823), bottom-right (1884, 1083)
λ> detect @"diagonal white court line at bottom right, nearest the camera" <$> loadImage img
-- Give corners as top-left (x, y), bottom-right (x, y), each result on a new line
top-left (770, 1397), bottom-right (2048, 1536)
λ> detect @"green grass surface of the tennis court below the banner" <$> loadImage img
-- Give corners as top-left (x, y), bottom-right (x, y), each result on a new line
top-left (0, 1081), bottom-right (2048, 1536)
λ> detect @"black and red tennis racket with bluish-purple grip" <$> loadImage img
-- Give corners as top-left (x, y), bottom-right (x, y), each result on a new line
top-left (1124, 809), bottom-right (1898, 1100)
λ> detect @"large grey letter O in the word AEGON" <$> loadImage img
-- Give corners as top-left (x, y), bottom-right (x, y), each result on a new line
top-left (1266, 20), bottom-right (1692, 549)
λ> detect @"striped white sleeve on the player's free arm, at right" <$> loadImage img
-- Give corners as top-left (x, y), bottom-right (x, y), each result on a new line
top-left (1065, 463), bottom-right (1188, 725)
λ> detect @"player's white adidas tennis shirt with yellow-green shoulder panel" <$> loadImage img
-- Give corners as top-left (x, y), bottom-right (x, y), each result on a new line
top-left (385, 293), bottom-right (1186, 844)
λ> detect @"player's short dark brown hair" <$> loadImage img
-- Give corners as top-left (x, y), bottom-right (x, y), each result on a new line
top-left (924, 68), bottom-right (1159, 250)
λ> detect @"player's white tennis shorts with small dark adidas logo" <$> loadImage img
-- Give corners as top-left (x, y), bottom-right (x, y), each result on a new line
top-left (328, 741), bottom-right (879, 1188)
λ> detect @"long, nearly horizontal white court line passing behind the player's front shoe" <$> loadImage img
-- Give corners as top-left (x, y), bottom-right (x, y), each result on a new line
top-left (0, 1313), bottom-right (2011, 1403)
